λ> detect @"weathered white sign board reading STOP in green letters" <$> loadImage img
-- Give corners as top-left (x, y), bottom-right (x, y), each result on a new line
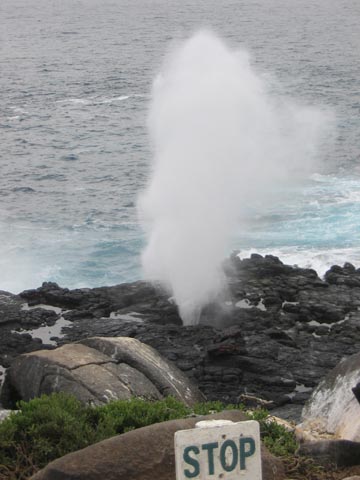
top-left (175, 420), bottom-right (262, 480)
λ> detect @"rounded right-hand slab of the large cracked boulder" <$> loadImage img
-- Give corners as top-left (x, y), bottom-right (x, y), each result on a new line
top-left (82, 337), bottom-right (204, 405)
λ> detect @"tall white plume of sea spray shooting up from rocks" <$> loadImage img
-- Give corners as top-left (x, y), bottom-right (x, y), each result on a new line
top-left (139, 32), bottom-right (332, 324)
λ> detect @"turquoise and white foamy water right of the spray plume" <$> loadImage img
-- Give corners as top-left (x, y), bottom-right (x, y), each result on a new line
top-left (233, 174), bottom-right (360, 275)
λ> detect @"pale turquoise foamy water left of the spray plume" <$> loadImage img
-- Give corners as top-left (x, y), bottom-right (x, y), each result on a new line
top-left (0, 221), bottom-right (141, 293)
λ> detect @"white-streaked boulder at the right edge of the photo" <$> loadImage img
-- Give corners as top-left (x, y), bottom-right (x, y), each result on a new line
top-left (299, 353), bottom-right (360, 442)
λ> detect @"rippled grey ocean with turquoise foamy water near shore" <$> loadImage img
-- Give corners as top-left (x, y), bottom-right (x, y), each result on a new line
top-left (0, 0), bottom-right (360, 293)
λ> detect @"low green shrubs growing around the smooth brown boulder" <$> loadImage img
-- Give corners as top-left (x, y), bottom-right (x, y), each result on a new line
top-left (0, 394), bottom-right (308, 480)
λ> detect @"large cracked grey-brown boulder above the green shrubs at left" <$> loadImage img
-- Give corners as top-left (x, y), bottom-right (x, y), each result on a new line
top-left (5, 338), bottom-right (203, 405)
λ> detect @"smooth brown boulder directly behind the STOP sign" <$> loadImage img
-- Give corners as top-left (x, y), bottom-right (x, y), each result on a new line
top-left (32, 411), bottom-right (285, 480)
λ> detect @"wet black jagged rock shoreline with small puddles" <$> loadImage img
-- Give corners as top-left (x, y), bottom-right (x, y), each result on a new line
top-left (0, 255), bottom-right (360, 419)
